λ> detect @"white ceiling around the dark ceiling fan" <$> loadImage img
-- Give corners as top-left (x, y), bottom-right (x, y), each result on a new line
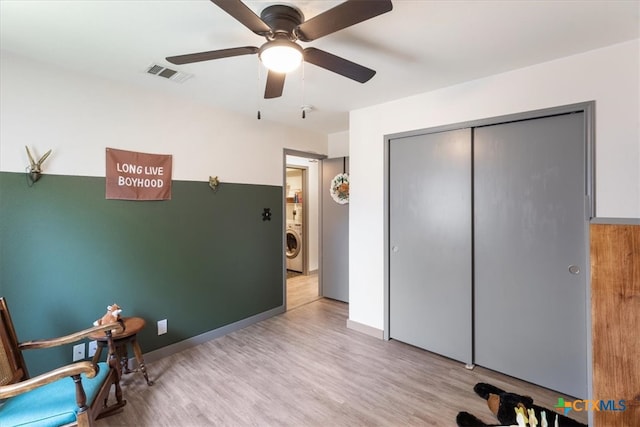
top-left (0, 0), bottom-right (640, 133)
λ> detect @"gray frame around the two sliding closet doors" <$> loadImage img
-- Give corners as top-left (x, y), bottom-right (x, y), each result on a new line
top-left (383, 101), bottom-right (596, 398)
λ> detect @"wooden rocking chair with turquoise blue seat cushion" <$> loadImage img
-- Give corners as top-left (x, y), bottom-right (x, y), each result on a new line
top-left (0, 297), bottom-right (127, 427)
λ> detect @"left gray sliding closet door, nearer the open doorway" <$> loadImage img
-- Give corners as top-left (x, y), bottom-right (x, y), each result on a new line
top-left (389, 129), bottom-right (472, 363)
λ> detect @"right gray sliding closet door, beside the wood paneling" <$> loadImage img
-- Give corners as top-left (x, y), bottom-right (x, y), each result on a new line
top-left (474, 113), bottom-right (587, 398)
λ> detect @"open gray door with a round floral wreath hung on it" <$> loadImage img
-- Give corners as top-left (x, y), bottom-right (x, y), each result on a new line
top-left (321, 157), bottom-right (349, 302)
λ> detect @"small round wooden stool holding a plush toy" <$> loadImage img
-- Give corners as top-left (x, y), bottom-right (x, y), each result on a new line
top-left (90, 317), bottom-right (153, 385)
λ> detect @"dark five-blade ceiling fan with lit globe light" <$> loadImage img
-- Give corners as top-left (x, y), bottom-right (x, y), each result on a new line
top-left (166, 0), bottom-right (393, 99)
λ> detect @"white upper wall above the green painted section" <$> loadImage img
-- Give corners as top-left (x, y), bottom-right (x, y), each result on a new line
top-left (0, 51), bottom-right (327, 186)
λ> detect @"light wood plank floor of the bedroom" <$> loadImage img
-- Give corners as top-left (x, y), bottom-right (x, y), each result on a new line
top-left (98, 299), bottom-right (586, 427)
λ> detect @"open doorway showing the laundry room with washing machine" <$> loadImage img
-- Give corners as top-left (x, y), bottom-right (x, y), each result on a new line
top-left (283, 150), bottom-right (324, 310)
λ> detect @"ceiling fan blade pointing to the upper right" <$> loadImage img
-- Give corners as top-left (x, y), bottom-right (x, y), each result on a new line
top-left (298, 0), bottom-right (393, 42)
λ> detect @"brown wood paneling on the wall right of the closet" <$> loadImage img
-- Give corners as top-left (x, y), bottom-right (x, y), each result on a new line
top-left (591, 224), bottom-right (640, 427)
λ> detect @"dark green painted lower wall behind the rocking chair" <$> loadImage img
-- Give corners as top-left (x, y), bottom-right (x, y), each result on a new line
top-left (0, 172), bottom-right (284, 375)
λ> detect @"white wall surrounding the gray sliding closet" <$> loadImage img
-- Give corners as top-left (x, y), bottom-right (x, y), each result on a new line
top-left (349, 40), bottom-right (640, 329)
